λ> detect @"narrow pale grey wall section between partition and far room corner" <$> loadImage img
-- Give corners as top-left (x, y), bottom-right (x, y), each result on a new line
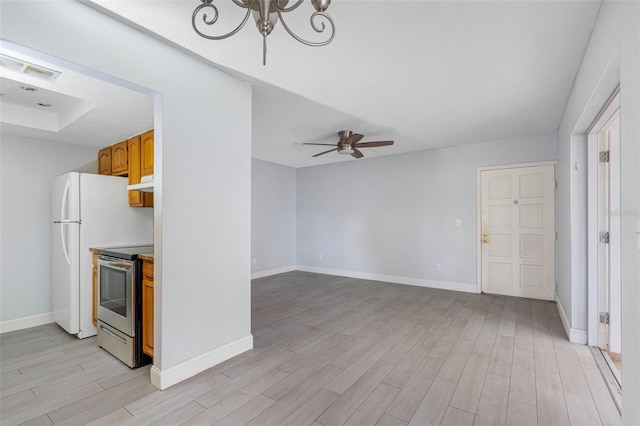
top-left (251, 159), bottom-right (296, 272)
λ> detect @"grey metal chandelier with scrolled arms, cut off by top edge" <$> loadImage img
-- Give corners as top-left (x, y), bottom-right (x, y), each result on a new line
top-left (191, 0), bottom-right (336, 65)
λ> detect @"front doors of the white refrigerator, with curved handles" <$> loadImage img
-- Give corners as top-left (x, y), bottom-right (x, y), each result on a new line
top-left (51, 173), bottom-right (81, 334)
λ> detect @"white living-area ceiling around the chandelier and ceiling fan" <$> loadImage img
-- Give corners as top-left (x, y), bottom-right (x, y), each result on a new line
top-left (2, 0), bottom-right (600, 167)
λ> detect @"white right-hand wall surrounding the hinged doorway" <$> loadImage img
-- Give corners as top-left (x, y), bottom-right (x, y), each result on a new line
top-left (557, 1), bottom-right (640, 425)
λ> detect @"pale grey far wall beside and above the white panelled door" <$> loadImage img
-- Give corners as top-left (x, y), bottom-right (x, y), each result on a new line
top-left (297, 134), bottom-right (556, 285)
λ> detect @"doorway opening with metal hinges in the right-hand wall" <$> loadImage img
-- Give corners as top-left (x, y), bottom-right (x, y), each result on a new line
top-left (587, 90), bottom-right (622, 408)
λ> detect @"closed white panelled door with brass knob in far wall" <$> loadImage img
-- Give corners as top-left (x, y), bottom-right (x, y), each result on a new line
top-left (480, 165), bottom-right (556, 300)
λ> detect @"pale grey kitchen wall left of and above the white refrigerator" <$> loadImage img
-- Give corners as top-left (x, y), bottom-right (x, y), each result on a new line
top-left (0, 134), bottom-right (98, 322)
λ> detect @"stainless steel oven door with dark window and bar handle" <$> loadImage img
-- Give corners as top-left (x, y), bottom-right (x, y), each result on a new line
top-left (98, 256), bottom-right (136, 337)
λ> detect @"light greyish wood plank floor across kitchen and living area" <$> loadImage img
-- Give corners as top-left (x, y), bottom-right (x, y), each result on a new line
top-left (0, 272), bottom-right (620, 426)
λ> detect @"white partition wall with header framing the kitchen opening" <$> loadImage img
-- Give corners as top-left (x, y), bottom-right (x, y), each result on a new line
top-left (0, 1), bottom-right (252, 387)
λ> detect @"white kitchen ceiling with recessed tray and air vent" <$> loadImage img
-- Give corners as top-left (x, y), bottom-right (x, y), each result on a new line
top-left (0, 43), bottom-right (153, 148)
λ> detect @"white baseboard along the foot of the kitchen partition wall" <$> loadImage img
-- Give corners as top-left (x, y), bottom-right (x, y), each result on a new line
top-left (150, 334), bottom-right (253, 390)
